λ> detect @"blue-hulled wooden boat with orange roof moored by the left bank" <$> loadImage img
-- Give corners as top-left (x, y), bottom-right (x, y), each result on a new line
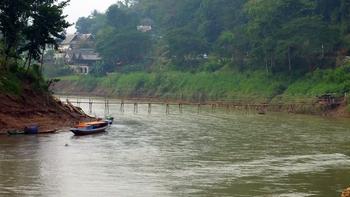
top-left (70, 121), bottom-right (109, 135)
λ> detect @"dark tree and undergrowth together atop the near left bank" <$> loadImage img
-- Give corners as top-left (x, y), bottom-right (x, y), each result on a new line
top-left (0, 0), bottom-right (69, 95)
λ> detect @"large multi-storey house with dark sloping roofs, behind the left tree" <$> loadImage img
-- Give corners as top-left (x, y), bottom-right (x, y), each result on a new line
top-left (55, 33), bottom-right (101, 74)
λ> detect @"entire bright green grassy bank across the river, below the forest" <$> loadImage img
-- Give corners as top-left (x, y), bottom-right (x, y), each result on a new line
top-left (55, 65), bottom-right (350, 102)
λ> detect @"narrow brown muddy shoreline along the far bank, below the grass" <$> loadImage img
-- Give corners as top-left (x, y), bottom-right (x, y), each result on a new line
top-left (54, 92), bottom-right (350, 118)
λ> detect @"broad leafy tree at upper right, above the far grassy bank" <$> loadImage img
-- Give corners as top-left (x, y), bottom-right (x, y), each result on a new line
top-left (246, 0), bottom-right (336, 71)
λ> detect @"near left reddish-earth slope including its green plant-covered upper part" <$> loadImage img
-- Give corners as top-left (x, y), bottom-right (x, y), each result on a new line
top-left (0, 73), bottom-right (89, 134)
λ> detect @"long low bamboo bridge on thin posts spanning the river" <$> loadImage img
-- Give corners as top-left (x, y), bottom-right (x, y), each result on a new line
top-left (56, 96), bottom-right (347, 114)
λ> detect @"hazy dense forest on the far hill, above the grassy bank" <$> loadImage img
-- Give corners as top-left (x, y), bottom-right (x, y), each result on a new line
top-left (76, 0), bottom-right (350, 74)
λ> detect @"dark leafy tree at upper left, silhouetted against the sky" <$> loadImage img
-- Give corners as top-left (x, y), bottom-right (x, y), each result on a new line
top-left (0, 0), bottom-right (69, 70)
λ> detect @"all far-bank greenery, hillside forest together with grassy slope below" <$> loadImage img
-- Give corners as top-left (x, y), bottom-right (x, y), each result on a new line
top-left (56, 0), bottom-right (350, 102)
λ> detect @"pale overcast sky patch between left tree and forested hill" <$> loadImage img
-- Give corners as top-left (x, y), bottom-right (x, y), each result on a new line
top-left (65, 0), bottom-right (118, 33)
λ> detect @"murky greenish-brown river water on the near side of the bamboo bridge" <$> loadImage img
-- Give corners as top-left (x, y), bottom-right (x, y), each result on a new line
top-left (0, 98), bottom-right (350, 197)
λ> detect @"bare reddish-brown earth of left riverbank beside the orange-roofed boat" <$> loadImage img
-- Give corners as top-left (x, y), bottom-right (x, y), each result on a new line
top-left (0, 88), bottom-right (93, 134)
